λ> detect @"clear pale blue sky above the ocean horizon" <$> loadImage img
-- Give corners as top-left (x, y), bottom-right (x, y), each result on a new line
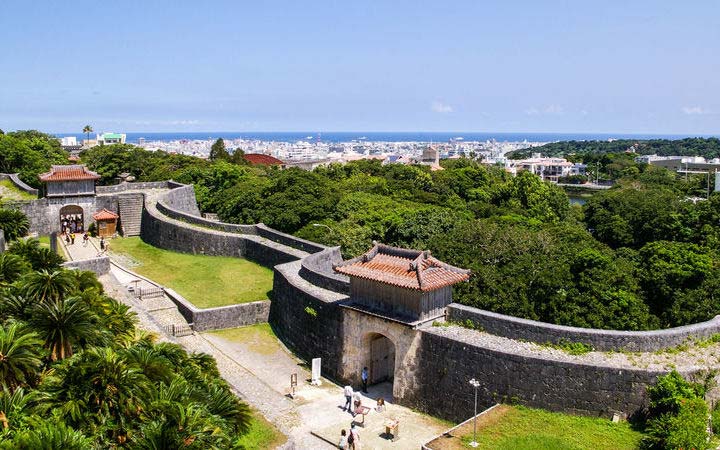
top-left (0, 0), bottom-right (720, 135)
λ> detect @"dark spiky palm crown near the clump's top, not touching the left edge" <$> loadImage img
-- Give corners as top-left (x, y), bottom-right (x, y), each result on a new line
top-left (29, 297), bottom-right (97, 361)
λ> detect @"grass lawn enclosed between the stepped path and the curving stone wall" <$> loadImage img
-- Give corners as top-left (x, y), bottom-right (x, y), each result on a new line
top-left (110, 237), bottom-right (273, 308)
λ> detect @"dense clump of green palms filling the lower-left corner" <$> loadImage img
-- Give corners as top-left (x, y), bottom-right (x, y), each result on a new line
top-left (0, 234), bottom-right (251, 450)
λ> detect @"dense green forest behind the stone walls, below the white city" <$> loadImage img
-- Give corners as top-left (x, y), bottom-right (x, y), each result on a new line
top-left (70, 139), bottom-right (720, 330)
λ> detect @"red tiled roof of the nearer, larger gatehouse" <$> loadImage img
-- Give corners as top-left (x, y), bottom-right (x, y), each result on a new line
top-left (334, 244), bottom-right (470, 291)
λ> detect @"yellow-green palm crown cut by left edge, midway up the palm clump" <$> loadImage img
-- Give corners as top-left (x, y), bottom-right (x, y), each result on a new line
top-left (0, 323), bottom-right (42, 387)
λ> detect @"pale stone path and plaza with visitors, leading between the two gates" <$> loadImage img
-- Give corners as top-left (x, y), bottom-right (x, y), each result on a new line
top-left (62, 235), bottom-right (448, 450)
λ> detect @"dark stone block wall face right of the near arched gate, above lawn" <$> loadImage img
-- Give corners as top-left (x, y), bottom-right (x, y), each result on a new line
top-left (404, 330), bottom-right (665, 421)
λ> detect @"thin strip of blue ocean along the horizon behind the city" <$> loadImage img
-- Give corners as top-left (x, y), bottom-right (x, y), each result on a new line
top-left (55, 131), bottom-right (710, 143)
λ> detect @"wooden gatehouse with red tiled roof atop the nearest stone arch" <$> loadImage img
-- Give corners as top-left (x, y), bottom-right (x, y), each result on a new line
top-left (333, 244), bottom-right (470, 323)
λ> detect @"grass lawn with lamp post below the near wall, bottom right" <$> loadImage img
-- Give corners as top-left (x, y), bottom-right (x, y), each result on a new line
top-left (429, 405), bottom-right (643, 450)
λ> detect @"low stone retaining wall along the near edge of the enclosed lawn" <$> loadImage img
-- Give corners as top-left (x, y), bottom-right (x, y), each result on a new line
top-left (165, 288), bottom-right (270, 331)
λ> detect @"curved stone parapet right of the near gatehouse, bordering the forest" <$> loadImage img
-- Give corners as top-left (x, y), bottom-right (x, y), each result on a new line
top-left (447, 303), bottom-right (720, 352)
